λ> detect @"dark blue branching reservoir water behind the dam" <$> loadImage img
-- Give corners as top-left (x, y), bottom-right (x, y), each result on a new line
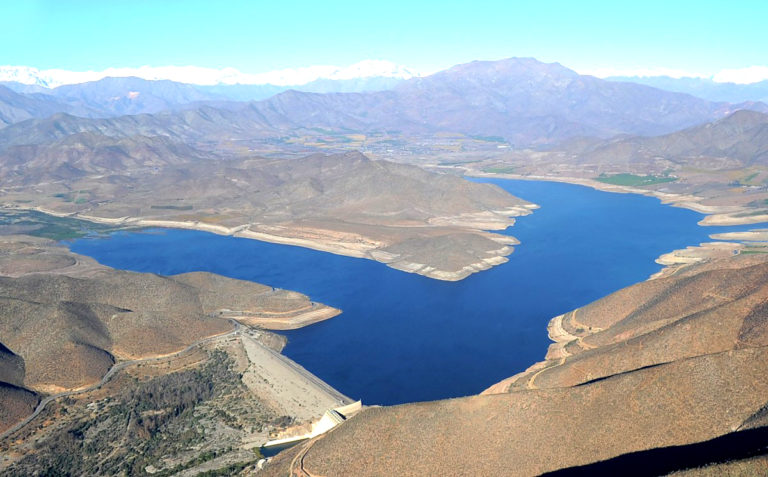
top-left (71, 180), bottom-right (760, 404)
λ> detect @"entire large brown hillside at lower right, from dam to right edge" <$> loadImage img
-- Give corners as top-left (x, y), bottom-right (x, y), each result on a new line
top-left (268, 255), bottom-right (768, 476)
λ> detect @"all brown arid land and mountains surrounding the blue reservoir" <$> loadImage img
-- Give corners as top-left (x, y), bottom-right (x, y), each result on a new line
top-left (0, 58), bottom-right (768, 477)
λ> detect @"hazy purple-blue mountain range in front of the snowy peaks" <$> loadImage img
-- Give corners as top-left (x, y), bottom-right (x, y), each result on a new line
top-left (0, 58), bottom-right (767, 146)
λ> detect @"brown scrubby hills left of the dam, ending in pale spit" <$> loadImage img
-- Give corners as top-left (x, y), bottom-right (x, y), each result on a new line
top-left (0, 236), bottom-right (339, 429)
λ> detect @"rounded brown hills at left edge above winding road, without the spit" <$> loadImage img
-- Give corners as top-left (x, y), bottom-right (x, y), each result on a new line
top-left (0, 271), bottom-right (231, 391)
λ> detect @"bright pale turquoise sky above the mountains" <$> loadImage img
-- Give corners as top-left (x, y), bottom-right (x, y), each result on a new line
top-left (6, 0), bottom-right (768, 74)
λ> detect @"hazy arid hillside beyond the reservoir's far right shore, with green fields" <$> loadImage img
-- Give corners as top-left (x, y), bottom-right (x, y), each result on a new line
top-left (460, 110), bottom-right (768, 225)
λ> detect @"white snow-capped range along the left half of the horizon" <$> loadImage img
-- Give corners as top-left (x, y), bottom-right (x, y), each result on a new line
top-left (0, 60), bottom-right (420, 88)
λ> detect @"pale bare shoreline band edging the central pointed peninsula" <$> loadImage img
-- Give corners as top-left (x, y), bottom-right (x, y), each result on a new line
top-left (10, 204), bottom-right (538, 281)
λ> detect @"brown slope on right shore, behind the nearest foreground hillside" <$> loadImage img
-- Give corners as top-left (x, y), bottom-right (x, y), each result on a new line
top-left (496, 255), bottom-right (768, 389)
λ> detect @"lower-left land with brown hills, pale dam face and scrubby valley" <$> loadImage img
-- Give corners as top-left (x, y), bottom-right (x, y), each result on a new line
top-left (0, 235), bottom-right (352, 475)
